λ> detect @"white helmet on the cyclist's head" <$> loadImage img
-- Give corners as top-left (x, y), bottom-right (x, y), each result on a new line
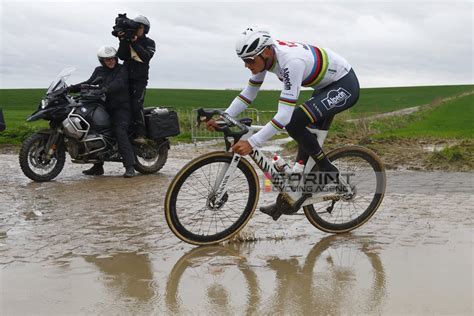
top-left (235, 25), bottom-right (273, 58)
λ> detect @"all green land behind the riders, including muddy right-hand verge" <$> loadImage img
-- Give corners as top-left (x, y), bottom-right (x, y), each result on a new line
top-left (0, 85), bottom-right (474, 171)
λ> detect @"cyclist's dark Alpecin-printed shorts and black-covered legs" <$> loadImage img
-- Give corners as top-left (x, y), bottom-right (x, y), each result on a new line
top-left (285, 69), bottom-right (360, 161)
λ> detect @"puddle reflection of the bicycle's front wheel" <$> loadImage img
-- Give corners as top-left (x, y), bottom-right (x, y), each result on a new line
top-left (165, 244), bottom-right (260, 314)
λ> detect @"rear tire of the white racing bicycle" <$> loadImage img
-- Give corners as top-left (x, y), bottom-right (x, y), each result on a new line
top-left (303, 146), bottom-right (386, 233)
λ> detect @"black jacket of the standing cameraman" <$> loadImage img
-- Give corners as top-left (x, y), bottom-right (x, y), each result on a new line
top-left (117, 35), bottom-right (155, 84)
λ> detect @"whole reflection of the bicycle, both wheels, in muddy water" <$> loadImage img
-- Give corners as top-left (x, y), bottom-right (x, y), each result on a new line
top-left (165, 235), bottom-right (385, 314)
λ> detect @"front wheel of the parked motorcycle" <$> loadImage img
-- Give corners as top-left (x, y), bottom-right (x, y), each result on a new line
top-left (19, 134), bottom-right (66, 182)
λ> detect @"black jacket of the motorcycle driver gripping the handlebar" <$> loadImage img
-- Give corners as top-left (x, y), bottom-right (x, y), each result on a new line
top-left (69, 63), bottom-right (130, 111)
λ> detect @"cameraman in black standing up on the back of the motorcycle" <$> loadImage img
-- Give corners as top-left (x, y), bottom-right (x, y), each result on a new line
top-left (117, 15), bottom-right (155, 144)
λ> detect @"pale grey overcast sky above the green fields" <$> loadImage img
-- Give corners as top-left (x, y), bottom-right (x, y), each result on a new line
top-left (0, 0), bottom-right (474, 89)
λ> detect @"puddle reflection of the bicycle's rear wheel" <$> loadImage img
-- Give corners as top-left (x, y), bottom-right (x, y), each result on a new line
top-left (269, 235), bottom-right (385, 314)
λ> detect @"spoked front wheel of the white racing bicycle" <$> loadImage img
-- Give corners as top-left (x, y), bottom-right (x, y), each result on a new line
top-left (165, 152), bottom-right (260, 245)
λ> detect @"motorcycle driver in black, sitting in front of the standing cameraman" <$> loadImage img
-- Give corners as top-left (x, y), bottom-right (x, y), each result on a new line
top-left (68, 46), bottom-right (135, 178)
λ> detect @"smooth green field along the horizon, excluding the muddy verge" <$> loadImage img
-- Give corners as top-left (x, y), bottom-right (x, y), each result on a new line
top-left (0, 85), bottom-right (474, 144)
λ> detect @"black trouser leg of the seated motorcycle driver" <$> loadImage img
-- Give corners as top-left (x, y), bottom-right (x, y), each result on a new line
top-left (111, 108), bottom-right (135, 168)
